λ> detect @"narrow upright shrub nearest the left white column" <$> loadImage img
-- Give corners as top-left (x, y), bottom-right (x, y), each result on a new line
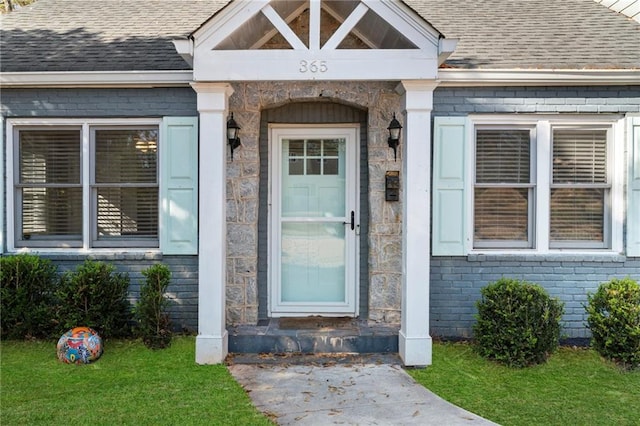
top-left (135, 264), bottom-right (171, 349)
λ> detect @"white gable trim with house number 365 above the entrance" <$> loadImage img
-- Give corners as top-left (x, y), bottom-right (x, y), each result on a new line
top-left (186, 0), bottom-right (444, 81)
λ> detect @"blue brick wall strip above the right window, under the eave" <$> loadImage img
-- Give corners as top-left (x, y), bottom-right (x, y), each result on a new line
top-left (433, 86), bottom-right (640, 116)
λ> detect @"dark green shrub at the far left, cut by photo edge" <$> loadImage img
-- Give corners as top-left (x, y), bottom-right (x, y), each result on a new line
top-left (0, 254), bottom-right (59, 339)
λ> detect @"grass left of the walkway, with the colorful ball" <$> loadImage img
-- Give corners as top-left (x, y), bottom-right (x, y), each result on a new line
top-left (0, 337), bottom-right (272, 425)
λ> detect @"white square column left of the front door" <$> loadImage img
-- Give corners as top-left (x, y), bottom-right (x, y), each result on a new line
top-left (192, 83), bottom-right (233, 364)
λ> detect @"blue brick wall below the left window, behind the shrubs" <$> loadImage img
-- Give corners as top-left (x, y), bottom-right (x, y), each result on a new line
top-left (42, 253), bottom-right (198, 332)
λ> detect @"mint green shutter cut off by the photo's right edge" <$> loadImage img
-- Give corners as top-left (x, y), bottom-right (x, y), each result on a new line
top-left (627, 117), bottom-right (640, 256)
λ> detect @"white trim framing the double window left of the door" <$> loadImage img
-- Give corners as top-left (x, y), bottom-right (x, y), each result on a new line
top-left (5, 117), bottom-right (163, 254)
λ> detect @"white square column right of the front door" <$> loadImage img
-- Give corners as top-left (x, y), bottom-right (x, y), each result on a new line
top-left (396, 81), bottom-right (437, 366)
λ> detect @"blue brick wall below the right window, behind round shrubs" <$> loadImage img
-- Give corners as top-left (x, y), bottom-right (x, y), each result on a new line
top-left (431, 255), bottom-right (640, 338)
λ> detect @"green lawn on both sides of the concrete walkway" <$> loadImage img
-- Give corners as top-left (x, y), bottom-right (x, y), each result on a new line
top-left (0, 337), bottom-right (640, 426)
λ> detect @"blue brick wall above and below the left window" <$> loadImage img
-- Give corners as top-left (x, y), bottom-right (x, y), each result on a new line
top-left (0, 87), bottom-right (198, 331)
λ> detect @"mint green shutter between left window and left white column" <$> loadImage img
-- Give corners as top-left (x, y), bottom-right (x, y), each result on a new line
top-left (160, 117), bottom-right (198, 254)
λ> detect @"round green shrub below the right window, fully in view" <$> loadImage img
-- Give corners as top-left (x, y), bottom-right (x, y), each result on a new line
top-left (473, 278), bottom-right (564, 367)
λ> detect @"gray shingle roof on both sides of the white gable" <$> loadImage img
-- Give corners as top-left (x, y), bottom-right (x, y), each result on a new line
top-left (0, 0), bottom-right (640, 72)
